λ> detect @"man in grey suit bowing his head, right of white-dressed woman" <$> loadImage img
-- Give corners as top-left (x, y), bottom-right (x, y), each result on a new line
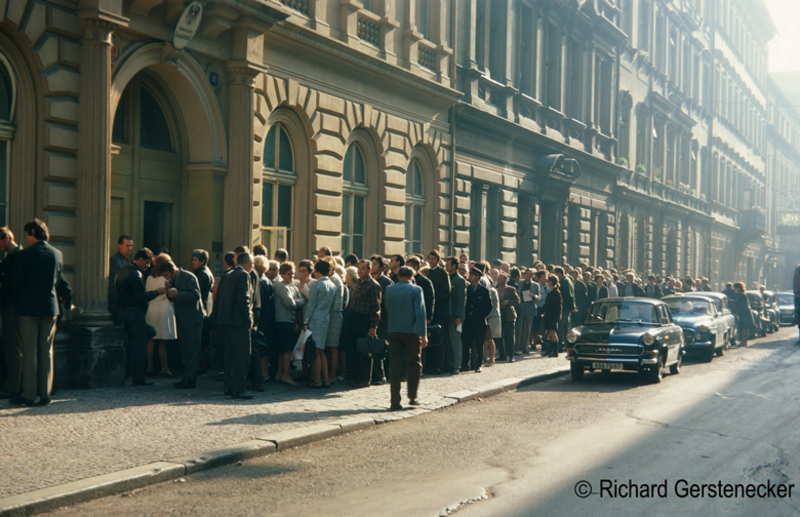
top-left (161, 260), bottom-right (206, 389)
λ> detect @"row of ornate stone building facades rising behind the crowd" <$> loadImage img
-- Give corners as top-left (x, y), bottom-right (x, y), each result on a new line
top-left (0, 0), bottom-right (798, 384)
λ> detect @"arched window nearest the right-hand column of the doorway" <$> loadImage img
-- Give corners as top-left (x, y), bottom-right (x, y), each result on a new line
top-left (261, 122), bottom-right (297, 251)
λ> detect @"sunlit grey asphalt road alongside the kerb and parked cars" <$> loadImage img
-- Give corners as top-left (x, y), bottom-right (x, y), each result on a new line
top-left (47, 328), bottom-right (800, 517)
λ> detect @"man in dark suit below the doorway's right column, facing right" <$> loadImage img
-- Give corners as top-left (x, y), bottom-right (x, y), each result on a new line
top-left (214, 253), bottom-right (253, 400)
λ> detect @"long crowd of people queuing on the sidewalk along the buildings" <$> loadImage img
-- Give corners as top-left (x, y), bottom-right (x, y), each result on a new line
top-left (0, 219), bottom-right (792, 409)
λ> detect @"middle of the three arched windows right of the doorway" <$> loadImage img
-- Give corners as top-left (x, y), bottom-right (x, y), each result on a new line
top-left (342, 144), bottom-right (369, 257)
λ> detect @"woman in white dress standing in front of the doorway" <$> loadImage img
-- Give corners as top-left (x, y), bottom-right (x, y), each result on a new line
top-left (145, 253), bottom-right (178, 377)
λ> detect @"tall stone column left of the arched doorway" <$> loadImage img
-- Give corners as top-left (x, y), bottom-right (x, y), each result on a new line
top-left (75, 18), bottom-right (116, 325)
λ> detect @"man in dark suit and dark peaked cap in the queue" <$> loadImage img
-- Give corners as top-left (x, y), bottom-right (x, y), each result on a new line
top-left (461, 267), bottom-right (492, 373)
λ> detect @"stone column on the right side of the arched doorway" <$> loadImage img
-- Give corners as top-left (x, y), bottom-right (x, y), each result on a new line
top-left (223, 61), bottom-right (260, 250)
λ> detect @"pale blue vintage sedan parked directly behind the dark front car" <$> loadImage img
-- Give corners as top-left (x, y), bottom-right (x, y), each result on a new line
top-left (661, 293), bottom-right (728, 362)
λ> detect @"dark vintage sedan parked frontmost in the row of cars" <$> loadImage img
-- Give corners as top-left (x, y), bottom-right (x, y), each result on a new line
top-left (567, 297), bottom-right (683, 383)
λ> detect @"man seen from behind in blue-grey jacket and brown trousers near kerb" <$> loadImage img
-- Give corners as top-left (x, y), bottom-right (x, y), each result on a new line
top-left (386, 266), bottom-right (428, 411)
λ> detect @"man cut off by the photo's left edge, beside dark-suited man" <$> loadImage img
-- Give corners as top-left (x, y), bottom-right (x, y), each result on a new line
top-left (0, 227), bottom-right (22, 398)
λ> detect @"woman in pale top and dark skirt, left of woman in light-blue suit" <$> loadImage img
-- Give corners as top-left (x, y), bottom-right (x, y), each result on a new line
top-left (274, 262), bottom-right (305, 386)
